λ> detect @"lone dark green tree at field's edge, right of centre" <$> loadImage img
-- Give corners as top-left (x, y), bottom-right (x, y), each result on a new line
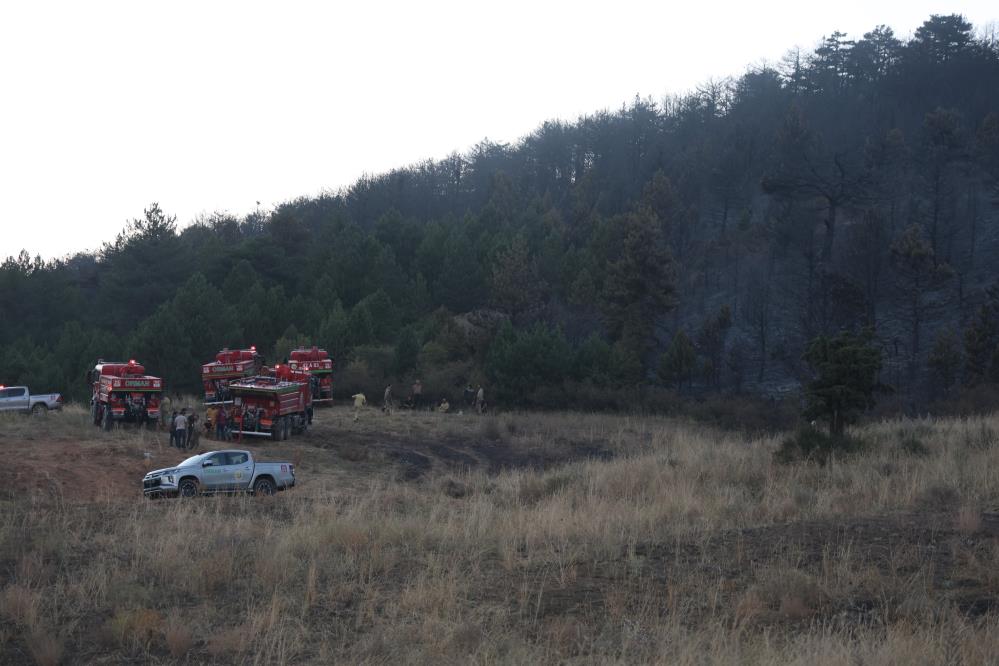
top-left (803, 330), bottom-right (888, 439)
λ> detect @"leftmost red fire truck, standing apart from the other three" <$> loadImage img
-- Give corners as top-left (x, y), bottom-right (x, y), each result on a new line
top-left (87, 359), bottom-right (163, 430)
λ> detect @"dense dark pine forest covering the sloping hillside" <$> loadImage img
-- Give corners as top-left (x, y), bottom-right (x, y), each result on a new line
top-left (0, 15), bottom-right (999, 409)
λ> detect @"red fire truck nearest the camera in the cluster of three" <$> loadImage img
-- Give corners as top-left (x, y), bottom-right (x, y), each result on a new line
top-left (229, 365), bottom-right (312, 441)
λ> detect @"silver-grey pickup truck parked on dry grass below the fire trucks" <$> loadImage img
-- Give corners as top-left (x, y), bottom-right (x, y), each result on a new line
top-left (142, 450), bottom-right (295, 497)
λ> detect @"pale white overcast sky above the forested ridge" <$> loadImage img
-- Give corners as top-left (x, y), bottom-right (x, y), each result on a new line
top-left (0, 0), bottom-right (999, 259)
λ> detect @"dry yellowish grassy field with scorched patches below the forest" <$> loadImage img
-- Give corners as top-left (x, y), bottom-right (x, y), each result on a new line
top-left (0, 407), bottom-right (999, 664)
